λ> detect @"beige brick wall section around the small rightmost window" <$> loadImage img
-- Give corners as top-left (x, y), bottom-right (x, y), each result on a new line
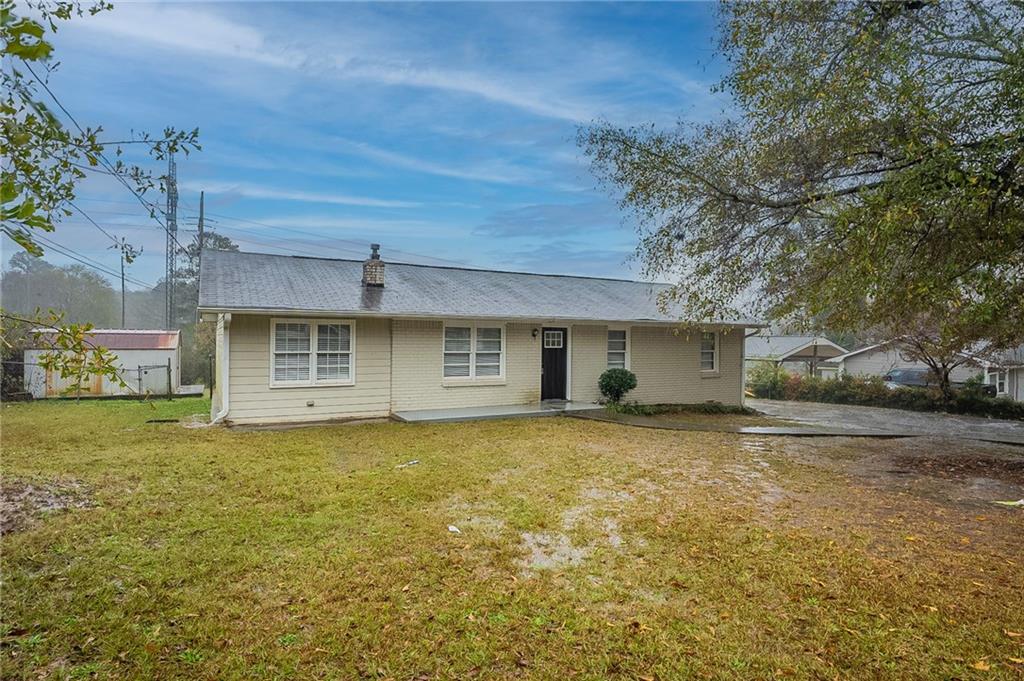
top-left (627, 327), bottom-right (743, 405)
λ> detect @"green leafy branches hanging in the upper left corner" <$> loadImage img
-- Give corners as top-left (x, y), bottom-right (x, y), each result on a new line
top-left (0, 0), bottom-right (200, 255)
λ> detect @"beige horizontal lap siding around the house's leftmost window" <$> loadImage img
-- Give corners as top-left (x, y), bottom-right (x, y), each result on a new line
top-left (227, 315), bottom-right (391, 423)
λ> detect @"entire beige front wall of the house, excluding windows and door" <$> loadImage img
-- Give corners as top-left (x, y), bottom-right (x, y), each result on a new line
top-left (216, 314), bottom-right (742, 423)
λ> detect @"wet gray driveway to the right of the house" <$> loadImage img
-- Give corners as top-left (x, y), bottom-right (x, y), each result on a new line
top-left (745, 399), bottom-right (1024, 444)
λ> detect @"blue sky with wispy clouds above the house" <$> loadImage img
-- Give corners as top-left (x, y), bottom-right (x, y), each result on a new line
top-left (4, 3), bottom-right (727, 283)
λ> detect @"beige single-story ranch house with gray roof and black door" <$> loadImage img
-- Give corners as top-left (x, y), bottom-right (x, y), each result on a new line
top-left (199, 245), bottom-right (758, 423)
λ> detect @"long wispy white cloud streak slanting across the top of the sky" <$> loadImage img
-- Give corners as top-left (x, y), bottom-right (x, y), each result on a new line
top-left (72, 4), bottom-right (708, 123)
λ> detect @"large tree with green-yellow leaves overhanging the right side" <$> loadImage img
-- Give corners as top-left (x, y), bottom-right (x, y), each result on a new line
top-left (580, 0), bottom-right (1024, 356)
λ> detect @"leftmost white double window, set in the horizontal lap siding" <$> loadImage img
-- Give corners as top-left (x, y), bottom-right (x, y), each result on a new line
top-left (270, 320), bottom-right (355, 387)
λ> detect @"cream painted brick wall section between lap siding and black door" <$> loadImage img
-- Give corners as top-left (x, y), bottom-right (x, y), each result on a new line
top-left (391, 320), bottom-right (541, 412)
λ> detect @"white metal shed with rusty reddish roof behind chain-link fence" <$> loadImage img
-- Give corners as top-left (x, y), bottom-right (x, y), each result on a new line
top-left (25, 329), bottom-right (181, 398)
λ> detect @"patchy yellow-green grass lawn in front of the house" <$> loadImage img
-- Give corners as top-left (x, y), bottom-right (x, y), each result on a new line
top-left (0, 399), bottom-right (1024, 679)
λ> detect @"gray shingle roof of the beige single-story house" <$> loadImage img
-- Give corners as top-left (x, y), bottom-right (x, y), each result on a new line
top-left (199, 251), bottom-right (758, 325)
